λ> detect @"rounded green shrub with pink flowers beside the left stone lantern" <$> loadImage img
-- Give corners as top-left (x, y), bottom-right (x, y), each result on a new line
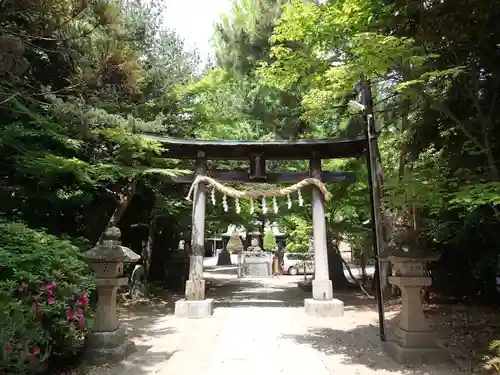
top-left (0, 221), bottom-right (94, 374)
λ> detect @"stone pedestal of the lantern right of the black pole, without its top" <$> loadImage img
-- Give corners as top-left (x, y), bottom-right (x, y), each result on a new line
top-left (386, 256), bottom-right (448, 365)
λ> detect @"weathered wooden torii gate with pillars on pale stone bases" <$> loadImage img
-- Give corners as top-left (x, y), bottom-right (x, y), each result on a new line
top-left (149, 128), bottom-right (381, 317)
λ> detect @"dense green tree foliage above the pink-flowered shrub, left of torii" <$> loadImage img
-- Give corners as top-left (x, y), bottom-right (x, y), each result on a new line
top-left (0, 0), bottom-right (196, 243)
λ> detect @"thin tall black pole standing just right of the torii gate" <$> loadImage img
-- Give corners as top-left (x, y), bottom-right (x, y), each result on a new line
top-left (361, 77), bottom-right (386, 341)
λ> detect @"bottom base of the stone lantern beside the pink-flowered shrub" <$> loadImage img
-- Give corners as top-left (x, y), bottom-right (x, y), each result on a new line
top-left (85, 327), bottom-right (136, 365)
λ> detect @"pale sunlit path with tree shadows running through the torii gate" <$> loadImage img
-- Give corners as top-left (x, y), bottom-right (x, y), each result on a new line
top-left (99, 268), bottom-right (462, 375)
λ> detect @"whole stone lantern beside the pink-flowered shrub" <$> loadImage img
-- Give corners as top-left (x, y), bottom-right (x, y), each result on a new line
top-left (83, 227), bottom-right (140, 363)
